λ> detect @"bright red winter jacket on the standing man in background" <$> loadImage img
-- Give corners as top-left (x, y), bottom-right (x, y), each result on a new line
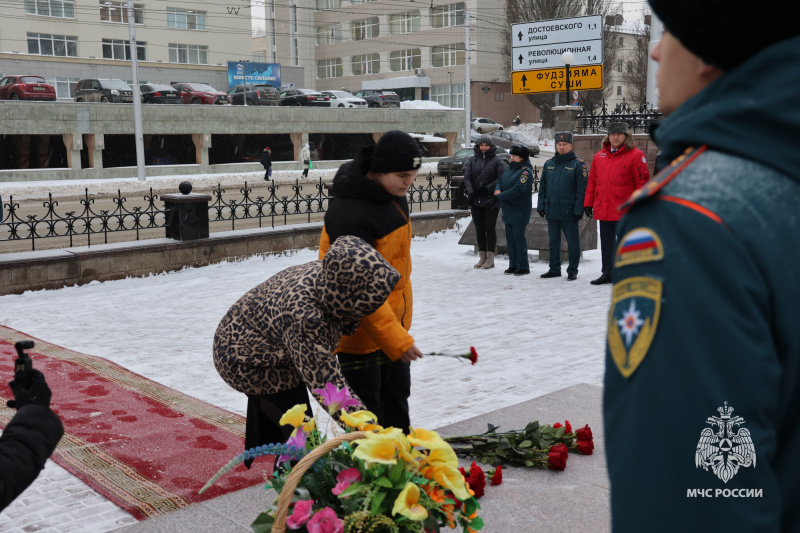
top-left (583, 135), bottom-right (650, 220)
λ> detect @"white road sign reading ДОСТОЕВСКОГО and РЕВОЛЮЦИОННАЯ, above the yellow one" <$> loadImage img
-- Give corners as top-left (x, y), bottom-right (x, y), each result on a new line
top-left (511, 15), bottom-right (603, 71)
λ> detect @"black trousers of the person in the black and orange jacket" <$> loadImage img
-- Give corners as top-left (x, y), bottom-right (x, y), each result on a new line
top-left (337, 350), bottom-right (411, 433)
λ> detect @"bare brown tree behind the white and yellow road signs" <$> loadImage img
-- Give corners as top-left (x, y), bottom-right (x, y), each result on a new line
top-left (502, 0), bottom-right (618, 127)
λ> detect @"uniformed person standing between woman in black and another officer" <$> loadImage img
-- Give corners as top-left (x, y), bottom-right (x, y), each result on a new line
top-left (494, 144), bottom-right (533, 276)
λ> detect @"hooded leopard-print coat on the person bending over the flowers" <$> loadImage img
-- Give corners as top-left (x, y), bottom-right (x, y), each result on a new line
top-left (214, 236), bottom-right (400, 409)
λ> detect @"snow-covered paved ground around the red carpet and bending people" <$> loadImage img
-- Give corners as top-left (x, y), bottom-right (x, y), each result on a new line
top-left (0, 219), bottom-right (611, 533)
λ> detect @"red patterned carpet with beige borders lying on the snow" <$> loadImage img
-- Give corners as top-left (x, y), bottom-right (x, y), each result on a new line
top-left (0, 325), bottom-right (272, 520)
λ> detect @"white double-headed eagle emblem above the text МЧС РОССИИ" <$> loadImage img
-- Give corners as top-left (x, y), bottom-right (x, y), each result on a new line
top-left (694, 402), bottom-right (756, 483)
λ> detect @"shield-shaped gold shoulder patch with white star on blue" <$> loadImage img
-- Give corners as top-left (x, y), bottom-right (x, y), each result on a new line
top-left (608, 277), bottom-right (662, 378)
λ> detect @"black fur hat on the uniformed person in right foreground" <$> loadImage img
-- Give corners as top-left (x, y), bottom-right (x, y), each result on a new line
top-left (650, 0), bottom-right (800, 70)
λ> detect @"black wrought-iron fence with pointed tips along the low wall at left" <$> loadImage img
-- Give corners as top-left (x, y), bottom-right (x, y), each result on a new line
top-left (0, 173), bottom-right (453, 250)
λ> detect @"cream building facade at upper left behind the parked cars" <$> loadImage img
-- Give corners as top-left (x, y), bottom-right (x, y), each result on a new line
top-left (0, 0), bottom-right (252, 99)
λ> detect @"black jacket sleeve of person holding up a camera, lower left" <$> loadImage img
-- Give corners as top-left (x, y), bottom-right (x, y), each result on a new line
top-left (0, 404), bottom-right (64, 511)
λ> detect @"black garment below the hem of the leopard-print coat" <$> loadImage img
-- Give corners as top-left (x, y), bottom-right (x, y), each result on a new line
top-left (244, 383), bottom-right (312, 468)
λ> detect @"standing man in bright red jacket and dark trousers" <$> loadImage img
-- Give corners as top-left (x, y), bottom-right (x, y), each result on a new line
top-left (583, 122), bottom-right (650, 285)
